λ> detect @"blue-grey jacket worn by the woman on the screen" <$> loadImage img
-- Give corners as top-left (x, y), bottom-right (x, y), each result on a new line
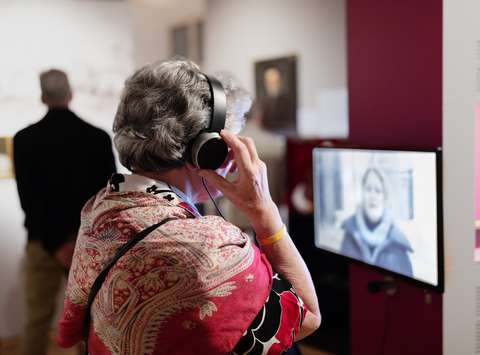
top-left (341, 216), bottom-right (413, 276)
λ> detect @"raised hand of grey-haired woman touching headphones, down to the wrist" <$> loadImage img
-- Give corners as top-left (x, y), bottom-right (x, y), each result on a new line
top-left (199, 130), bottom-right (282, 237)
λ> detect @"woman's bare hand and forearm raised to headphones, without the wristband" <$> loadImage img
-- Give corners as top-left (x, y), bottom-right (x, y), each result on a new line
top-left (199, 130), bottom-right (321, 340)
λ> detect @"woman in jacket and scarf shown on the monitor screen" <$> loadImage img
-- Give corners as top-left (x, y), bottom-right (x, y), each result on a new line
top-left (341, 167), bottom-right (413, 276)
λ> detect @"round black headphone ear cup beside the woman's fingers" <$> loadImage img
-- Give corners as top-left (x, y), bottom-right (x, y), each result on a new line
top-left (190, 132), bottom-right (228, 170)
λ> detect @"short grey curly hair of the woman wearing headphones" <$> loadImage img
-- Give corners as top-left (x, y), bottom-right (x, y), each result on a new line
top-left (113, 60), bottom-right (251, 171)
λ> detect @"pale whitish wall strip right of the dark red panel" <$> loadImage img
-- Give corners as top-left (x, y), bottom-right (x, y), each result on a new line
top-left (443, 0), bottom-right (480, 355)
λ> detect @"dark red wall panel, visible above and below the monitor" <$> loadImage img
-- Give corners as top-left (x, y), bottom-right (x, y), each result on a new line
top-left (347, 0), bottom-right (442, 355)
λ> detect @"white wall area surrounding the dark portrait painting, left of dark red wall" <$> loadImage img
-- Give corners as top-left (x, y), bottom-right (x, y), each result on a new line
top-left (204, 0), bottom-right (348, 138)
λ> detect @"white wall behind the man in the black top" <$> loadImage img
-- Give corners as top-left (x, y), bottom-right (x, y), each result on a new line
top-left (0, 0), bottom-right (134, 338)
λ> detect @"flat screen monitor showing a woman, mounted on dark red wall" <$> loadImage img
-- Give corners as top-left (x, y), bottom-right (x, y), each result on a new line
top-left (313, 148), bottom-right (443, 292)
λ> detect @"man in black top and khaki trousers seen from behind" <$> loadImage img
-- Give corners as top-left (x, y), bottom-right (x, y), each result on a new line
top-left (13, 69), bottom-right (116, 355)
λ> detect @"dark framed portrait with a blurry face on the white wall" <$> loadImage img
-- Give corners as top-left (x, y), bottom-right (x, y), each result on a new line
top-left (255, 56), bottom-right (297, 135)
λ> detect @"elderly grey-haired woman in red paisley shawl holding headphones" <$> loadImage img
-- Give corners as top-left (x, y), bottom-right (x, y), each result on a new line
top-left (59, 61), bottom-right (320, 355)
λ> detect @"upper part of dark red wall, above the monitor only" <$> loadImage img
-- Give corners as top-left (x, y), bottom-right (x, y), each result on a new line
top-left (347, 0), bottom-right (442, 147)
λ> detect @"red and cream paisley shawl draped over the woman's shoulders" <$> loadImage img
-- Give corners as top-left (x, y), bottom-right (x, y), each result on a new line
top-left (58, 175), bottom-right (271, 355)
